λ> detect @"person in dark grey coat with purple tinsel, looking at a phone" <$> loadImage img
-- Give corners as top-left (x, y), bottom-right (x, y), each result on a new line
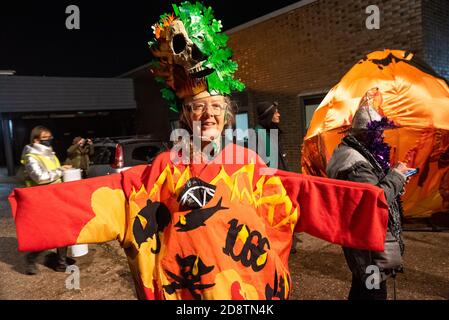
top-left (326, 88), bottom-right (411, 300)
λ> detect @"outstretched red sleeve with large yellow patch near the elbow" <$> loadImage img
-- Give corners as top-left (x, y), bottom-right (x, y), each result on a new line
top-left (9, 174), bottom-right (126, 251)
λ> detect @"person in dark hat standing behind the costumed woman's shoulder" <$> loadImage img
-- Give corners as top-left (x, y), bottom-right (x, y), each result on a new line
top-left (254, 102), bottom-right (289, 171)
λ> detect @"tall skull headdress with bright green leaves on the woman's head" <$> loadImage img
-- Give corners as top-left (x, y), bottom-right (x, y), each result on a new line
top-left (150, 2), bottom-right (244, 111)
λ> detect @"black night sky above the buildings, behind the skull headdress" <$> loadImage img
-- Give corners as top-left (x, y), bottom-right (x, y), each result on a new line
top-left (0, 0), bottom-right (299, 77)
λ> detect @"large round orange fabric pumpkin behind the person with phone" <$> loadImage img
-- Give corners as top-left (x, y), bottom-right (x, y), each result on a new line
top-left (301, 50), bottom-right (449, 217)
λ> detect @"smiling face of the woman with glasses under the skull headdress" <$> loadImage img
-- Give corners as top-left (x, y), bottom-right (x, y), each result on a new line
top-left (187, 96), bottom-right (228, 138)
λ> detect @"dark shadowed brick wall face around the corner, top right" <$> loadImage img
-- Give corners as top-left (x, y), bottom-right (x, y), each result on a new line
top-left (422, 0), bottom-right (449, 79)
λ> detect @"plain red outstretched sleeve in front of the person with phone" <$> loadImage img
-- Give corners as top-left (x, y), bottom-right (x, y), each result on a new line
top-left (278, 171), bottom-right (388, 251)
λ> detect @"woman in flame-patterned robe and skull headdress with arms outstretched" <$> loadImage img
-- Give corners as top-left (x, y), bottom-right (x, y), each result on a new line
top-left (10, 2), bottom-right (388, 299)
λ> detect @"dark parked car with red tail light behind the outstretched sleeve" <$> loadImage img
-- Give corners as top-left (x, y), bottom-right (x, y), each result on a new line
top-left (87, 136), bottom-right (169, 178)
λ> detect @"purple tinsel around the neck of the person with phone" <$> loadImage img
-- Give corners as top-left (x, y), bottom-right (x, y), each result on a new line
top-left (366, 117), bottom-right (396, 170)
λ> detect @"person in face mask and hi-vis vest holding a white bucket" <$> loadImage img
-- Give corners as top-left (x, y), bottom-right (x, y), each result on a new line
top-left (21, 126), bottom-right (71, 275)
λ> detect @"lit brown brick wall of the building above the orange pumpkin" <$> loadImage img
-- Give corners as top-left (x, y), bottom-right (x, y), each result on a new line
top-left (228, 0), bottom-right (424, 171)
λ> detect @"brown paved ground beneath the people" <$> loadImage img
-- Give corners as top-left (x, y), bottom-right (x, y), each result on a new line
top-left (0, 172), bottom-right (449, 300)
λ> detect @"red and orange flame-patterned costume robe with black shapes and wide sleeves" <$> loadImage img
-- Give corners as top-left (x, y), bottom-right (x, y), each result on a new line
top-left (10, 144), bottom-right (388, 300)
